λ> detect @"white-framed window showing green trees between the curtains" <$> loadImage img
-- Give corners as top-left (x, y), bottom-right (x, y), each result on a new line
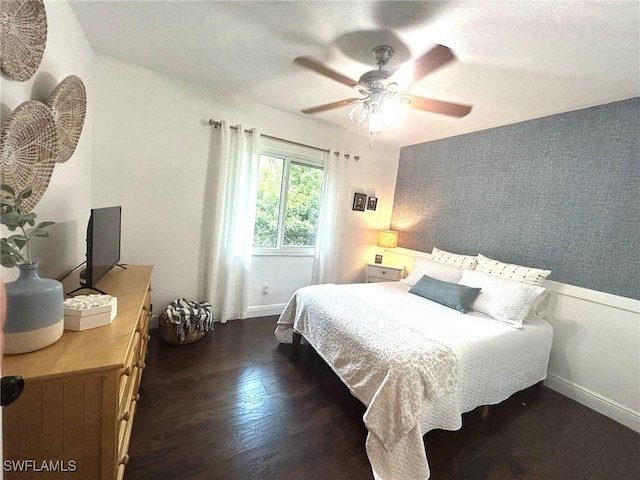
top-left (253, 145), bottom-right (323, 255)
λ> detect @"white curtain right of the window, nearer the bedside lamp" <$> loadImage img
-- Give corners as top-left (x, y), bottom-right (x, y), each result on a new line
top-left (311, 153), bottom-right (345, 284)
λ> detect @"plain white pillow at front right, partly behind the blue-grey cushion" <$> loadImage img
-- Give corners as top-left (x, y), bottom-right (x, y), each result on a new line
top-left (458, 270), bottom-right (546, 328)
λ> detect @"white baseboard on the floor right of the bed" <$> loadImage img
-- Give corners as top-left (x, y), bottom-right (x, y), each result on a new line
top-left (544, 373), bottom-right (640, 433)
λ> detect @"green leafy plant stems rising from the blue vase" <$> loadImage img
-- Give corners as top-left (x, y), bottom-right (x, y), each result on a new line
top-left (0, 184), bottom-right (55, 268)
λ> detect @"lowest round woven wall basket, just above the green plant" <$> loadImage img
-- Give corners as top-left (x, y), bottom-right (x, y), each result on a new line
top-left (0, 100), bottom-right (58, 212)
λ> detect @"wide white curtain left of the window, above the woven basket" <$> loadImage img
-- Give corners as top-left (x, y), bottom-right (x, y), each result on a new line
top-left (201, 121), bottom-right (260, 323)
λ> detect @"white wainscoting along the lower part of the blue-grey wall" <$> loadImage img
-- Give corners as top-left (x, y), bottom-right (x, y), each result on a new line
top-left (394, 248), bottom-right (640, 432)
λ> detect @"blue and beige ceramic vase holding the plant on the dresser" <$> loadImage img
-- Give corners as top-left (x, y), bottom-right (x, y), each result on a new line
top-left (4, 264), bottom-right (64, 354)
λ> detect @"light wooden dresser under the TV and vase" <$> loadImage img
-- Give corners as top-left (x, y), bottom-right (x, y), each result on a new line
top-left (2, 265), bottom-right (153, 480)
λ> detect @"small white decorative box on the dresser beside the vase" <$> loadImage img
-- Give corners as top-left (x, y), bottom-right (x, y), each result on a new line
top-left (64, 295), bottom-right (118, 332)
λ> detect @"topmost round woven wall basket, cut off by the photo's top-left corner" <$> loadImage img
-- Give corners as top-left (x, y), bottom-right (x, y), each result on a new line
top-left (0, 0), bottom-right (47, 82)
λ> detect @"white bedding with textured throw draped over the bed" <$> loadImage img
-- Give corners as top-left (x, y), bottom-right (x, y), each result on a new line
top-left (275, 282), bottom-right (552, 480)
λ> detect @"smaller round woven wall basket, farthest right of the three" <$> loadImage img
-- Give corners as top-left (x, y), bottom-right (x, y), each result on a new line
top-left (49, 75), bottom-right (87, 163)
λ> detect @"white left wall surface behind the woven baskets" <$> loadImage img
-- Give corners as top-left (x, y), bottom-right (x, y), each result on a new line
top-left (0, 1), bottom-right (94, 281)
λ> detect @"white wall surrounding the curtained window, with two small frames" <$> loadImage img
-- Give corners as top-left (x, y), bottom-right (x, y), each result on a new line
top-left (92, 55), bottom-right (400, 315)
